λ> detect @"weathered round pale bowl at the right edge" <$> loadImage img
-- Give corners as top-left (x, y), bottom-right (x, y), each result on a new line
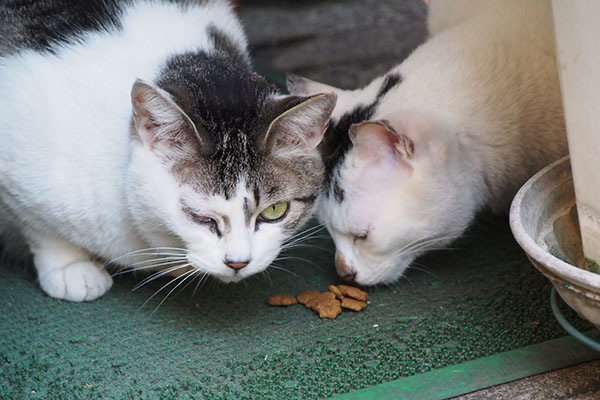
top-left (510, 156), bottom-right (600, 329)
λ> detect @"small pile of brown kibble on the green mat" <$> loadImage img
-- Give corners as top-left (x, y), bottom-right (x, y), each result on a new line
top-left (267, 285), bottom-right (367, 319)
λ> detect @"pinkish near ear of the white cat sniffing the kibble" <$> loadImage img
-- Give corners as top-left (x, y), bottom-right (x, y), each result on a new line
top-left (348, 120), bottom-right (415, 166)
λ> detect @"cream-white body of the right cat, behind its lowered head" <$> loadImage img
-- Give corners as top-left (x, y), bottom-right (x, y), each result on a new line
top-left (378, 0), bottom-right (567, 209)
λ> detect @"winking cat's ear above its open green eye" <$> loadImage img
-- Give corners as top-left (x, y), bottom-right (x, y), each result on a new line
top-left (263, 93), bottom-right (337, 157)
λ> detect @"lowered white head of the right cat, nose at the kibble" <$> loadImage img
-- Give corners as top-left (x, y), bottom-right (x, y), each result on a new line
top-left (290, 75), bottom-right (480, 285)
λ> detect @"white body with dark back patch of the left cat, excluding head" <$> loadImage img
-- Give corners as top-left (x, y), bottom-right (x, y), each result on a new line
top-left (0, 0), bottom-right (246, 255)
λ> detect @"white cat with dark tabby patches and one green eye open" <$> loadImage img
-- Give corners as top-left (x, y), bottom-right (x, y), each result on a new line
top-left (0, 0), bottom-right (336, 301)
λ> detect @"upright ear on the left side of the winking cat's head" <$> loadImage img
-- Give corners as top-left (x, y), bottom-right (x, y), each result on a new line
top-left (131, 79), bottom-right (208, 153)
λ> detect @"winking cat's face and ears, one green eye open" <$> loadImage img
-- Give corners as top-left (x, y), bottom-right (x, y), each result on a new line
top-left (128, 77), bottom-right (336, 282)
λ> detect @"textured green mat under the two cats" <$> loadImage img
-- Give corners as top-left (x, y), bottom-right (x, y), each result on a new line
top-left (0, 216), bottom-right (591, 399)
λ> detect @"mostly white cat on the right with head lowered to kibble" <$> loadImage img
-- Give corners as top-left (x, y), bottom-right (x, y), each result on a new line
top-left (288, 0), bottom-right (567, 285)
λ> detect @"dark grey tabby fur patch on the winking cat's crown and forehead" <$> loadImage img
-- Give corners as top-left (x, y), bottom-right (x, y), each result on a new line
top-left (156, 31), bottom-right (324, 233)
